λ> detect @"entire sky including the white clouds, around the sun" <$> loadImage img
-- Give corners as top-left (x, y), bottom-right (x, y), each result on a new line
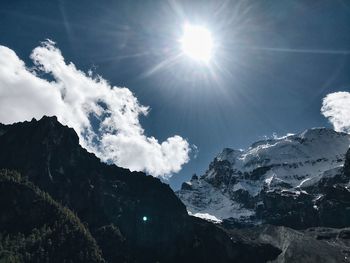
top-left (0, 0), bottom-right (350, 189)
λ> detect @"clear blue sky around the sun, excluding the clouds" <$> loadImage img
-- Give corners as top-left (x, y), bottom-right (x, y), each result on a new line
top-left (0, 0), bottom-right (350, 189)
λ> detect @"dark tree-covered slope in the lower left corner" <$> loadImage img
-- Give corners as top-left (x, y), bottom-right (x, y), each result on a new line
top-left (0, 170), bottom-right (104, 263)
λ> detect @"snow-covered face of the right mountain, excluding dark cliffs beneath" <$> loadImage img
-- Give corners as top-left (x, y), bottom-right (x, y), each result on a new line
top-left (177, 128), bottom-right (350, 225)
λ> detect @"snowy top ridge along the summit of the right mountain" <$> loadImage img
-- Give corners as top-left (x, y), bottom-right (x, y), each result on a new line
top-left (216, 128), bottom-right (350, 171)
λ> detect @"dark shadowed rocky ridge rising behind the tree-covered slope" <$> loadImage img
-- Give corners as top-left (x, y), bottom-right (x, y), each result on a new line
top-left (0, 117), bottom-right (280, 262)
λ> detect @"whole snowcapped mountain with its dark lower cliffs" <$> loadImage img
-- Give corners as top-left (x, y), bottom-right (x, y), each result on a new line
top-left (177, 128), bottom-right (350, 227)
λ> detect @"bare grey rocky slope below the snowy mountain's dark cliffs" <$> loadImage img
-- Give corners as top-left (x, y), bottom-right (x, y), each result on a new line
top-left (229, 225), bottom-right (350, 263)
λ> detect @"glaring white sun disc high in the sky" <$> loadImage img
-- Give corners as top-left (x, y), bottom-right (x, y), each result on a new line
top-left (180, 24), bottom-right (213, 63)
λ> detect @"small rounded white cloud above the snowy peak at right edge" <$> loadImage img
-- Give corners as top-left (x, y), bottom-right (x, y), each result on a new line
top-left (321, 91), bottom-right (350, 133)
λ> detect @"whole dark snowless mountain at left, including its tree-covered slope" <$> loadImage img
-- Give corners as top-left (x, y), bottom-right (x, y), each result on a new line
top-left (0, 117), bottom-right (281, 262)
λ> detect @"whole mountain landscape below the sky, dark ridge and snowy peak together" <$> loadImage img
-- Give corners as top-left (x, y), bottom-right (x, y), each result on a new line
top-left (0, 117), bottom-right (350, 263)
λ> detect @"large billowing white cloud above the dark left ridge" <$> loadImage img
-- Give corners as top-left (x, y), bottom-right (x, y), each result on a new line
top-left (0, 40), bottom-right (190, 176)
